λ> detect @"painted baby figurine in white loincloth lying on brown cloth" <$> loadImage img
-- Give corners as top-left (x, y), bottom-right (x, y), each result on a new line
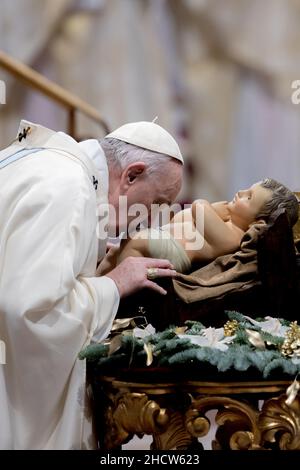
top-left (100, 178), bottom-right (298, 275)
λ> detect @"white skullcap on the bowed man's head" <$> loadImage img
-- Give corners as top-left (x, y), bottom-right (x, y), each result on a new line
top-left (105, 121), bottom-right (183, 163)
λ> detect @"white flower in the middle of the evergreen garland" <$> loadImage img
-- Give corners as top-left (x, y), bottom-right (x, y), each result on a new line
top-left (178, 327), bottom-right (235, 351)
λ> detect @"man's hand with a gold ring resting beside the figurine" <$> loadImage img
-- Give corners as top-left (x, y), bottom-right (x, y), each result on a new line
top-left (106, 256), bottom-right (177, 297)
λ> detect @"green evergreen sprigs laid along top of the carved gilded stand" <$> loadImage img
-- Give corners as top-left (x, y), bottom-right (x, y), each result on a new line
top-left (79, 312), bottom-right (300, 377)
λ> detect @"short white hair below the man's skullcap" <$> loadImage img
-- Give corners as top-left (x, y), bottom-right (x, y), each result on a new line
top-left (99, 138), bottom-right (181, 176)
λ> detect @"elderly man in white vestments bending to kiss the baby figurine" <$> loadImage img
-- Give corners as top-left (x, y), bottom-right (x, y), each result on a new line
top-left (0, 121), bottom-right (183, 449)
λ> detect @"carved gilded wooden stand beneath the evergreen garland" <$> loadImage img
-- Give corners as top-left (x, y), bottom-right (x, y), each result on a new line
top-left (94, 377), bottom-right (300, 450)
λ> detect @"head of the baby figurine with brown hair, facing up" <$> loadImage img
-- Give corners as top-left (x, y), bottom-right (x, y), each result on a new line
top-left (228, 178), bottom-right (299, 230)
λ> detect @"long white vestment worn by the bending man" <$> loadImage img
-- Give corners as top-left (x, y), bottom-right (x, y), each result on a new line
top-left (0, 121), bottom-right (119, 449)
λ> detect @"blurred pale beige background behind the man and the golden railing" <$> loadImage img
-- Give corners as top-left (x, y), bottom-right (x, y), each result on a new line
top-left (0, 0), bottom-right (300, 202)
